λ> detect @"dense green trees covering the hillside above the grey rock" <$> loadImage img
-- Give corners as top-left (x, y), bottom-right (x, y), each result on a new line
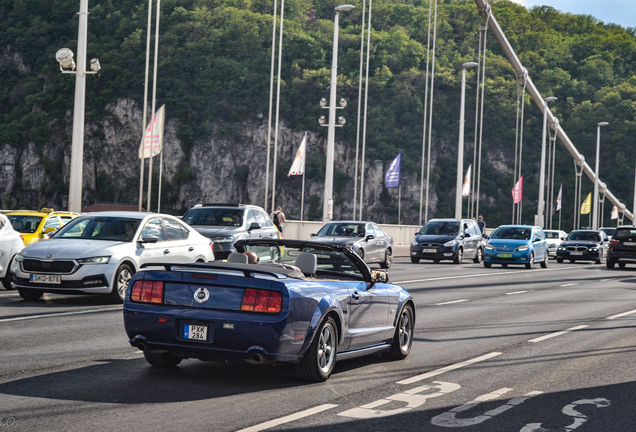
top-left (0, 0), bottom-right (636, 229)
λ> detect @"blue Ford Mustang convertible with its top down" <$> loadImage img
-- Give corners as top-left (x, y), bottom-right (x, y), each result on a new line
top-left (124, 240), bottom-right (415, 382)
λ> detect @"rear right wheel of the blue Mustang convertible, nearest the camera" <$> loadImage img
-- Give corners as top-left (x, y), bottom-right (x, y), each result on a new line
top-left (296, 317), bottom-right (338, 382)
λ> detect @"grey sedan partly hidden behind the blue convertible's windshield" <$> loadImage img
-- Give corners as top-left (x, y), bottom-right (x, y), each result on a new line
top-left (308, 221), bottom-right (393, 268)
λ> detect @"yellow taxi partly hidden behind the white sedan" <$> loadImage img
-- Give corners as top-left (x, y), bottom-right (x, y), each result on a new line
top-left (5, 208), bottom-right (80, 246)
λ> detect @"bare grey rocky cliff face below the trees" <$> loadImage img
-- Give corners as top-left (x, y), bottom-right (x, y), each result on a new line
top-left (0, 99), bottom-right (448, 223)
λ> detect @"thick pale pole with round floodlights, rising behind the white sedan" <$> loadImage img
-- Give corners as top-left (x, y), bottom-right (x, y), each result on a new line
top-left (55, 0), bottom-right (101, 213)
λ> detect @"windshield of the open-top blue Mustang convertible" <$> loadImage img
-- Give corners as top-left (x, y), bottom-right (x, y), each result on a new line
top-left (245, 244), bottom-right (364, 280)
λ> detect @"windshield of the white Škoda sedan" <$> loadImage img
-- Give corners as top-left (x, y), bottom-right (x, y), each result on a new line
top-left (55, 216), bottom-right (141, 242)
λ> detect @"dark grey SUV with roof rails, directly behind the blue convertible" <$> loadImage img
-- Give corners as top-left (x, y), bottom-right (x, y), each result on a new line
top-left (183, 204), bottom-right (281, 260)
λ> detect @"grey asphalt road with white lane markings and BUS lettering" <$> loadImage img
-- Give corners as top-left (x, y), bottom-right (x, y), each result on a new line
top-left (0, 258), bottom-right (636, 432)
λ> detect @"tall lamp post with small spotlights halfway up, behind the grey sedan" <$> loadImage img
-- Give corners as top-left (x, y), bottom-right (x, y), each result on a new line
top-left (322, 5), bottom-right (354, 223)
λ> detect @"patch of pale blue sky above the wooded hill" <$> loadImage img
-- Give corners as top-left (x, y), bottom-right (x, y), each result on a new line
top-left (513, 0), bottom-right (636, 27)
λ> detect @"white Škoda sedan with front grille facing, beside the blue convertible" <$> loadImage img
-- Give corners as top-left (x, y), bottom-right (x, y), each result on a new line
top-left (11, 212), bottom-right (214, 303)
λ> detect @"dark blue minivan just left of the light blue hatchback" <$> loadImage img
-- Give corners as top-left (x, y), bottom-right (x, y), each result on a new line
top-left (411, 219), bottom-right (484, 264)
